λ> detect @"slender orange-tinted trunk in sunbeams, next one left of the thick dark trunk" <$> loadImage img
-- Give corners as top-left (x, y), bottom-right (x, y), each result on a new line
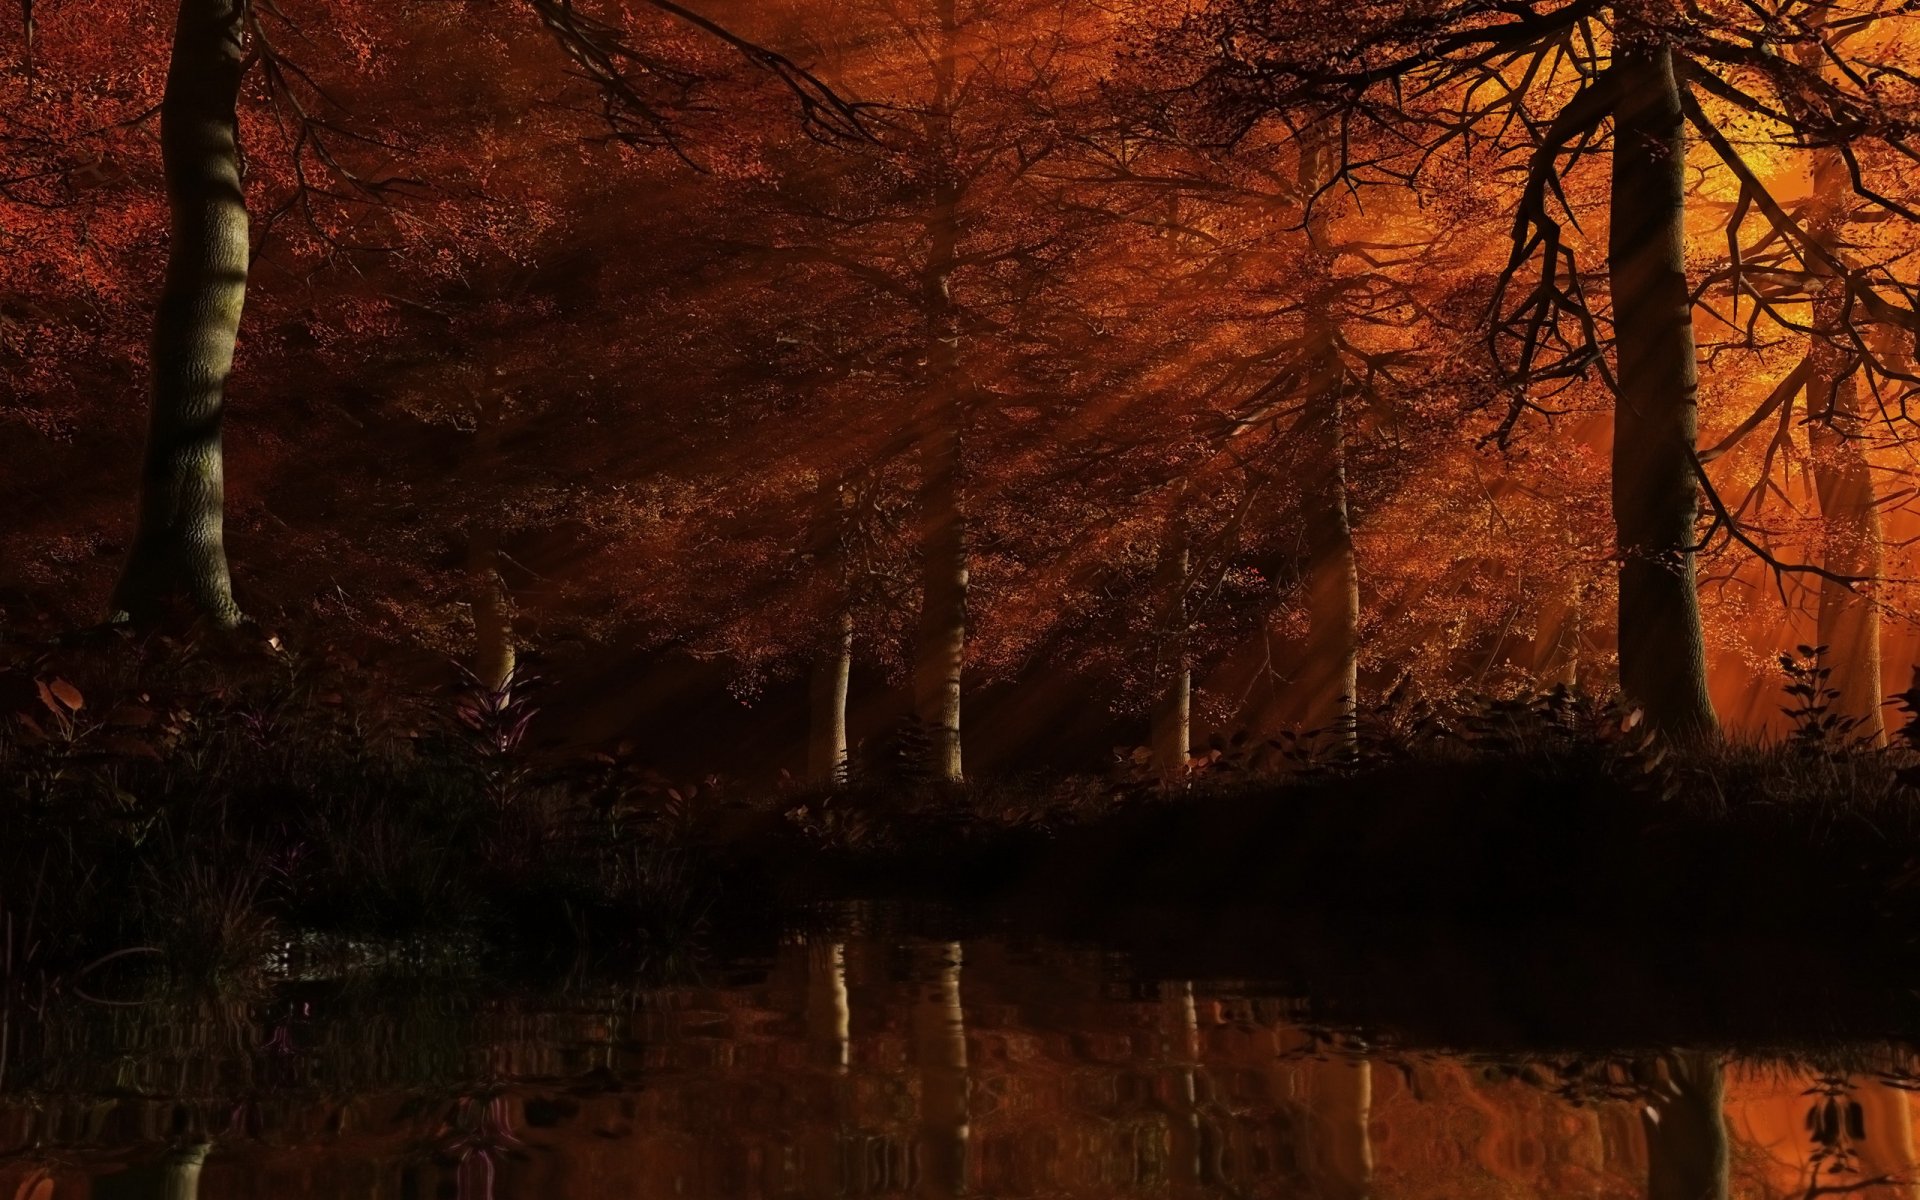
top-left (1300, 123), bottom-right (1359, 745)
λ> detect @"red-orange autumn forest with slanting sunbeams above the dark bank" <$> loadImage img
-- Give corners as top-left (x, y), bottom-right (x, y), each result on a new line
top-left (11, 0), bottom-right (1920, 894)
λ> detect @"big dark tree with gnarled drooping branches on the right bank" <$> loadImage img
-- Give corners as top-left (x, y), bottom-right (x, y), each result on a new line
top-left (1152, 0), bottom-right (1912, 739)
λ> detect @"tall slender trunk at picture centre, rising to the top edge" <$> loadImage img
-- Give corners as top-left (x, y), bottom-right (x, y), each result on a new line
top-left (914, 0), bottom-right (968, 783)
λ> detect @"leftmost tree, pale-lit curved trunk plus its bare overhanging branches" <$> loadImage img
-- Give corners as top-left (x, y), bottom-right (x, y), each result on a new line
top-left (16, 0), bottom-right (856, 626)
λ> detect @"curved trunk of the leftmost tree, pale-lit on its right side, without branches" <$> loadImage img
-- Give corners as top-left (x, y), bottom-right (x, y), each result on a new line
top-left (111, 0), bottom-right (248, 628)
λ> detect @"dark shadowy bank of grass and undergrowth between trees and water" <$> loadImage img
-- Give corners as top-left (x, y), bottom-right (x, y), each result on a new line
top-left (0, 625), bottom-right (1920, 1044)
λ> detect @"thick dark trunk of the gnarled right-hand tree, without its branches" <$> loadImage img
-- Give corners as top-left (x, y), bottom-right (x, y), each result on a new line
top-left (1607, 35), bottom-right (1716, 741)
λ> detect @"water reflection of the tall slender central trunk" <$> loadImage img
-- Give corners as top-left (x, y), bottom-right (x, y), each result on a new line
top-left (912, 943), bottom-right (972, 1198)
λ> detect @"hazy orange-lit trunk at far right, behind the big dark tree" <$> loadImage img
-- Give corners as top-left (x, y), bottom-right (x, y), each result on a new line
top-left (1801, 25), bottom-right (1887, 745)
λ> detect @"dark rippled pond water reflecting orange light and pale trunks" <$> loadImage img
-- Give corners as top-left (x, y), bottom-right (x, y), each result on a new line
top-left (0, 935), bottom-right (1920, 1200)
